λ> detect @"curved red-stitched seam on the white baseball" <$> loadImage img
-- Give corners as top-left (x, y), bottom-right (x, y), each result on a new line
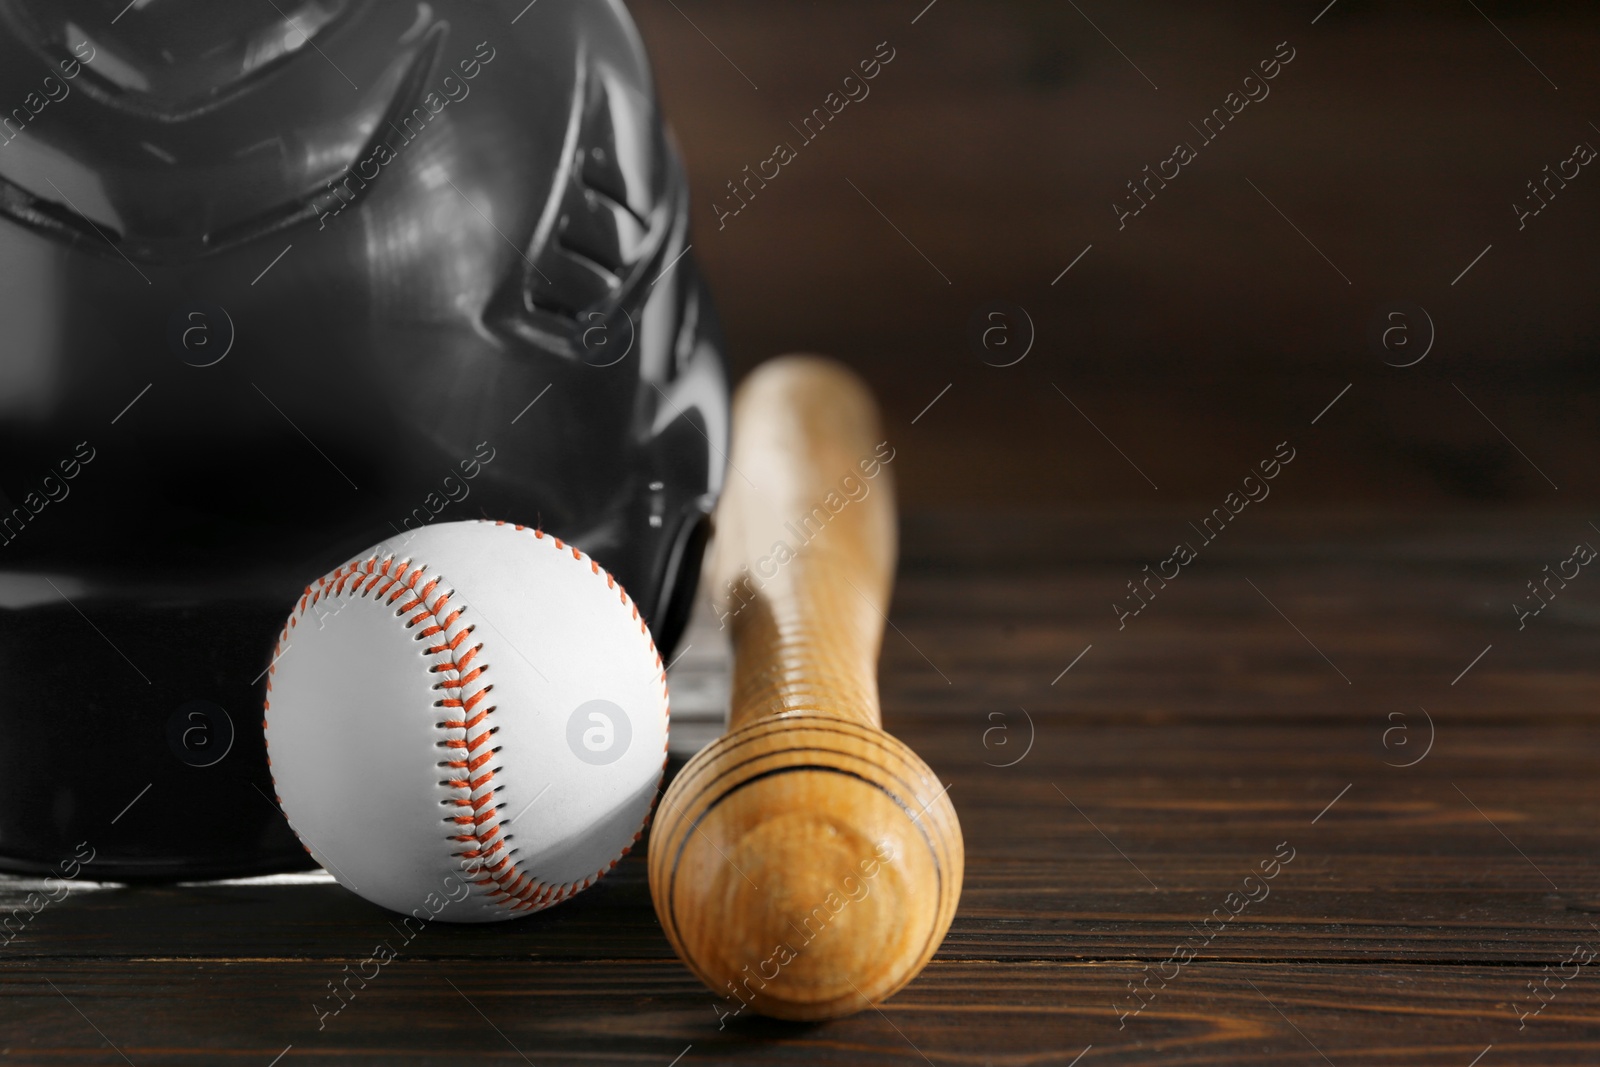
top-left (261, 520), bottom-right (670, 912)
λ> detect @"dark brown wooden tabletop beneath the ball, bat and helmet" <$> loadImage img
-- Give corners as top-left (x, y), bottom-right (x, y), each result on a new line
top-left (0, 504), bottom-right (1600, 1067)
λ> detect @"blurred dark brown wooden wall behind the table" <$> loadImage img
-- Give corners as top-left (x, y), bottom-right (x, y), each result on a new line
top-left (629, 0), bottom-right (1600, 510)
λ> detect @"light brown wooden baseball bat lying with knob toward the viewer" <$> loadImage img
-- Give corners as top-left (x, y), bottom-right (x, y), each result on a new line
top-left (650, 357), bottom-right (963, 1019)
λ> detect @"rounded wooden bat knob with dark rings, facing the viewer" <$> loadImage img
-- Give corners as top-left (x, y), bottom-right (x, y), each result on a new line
top-left (650, 712), bottom-right (963, 1019)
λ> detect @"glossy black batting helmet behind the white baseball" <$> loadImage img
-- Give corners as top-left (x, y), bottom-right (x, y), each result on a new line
top-left (0, 0), bottom-right (728, 878)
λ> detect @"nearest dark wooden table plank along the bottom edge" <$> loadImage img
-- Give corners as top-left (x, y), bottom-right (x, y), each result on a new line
top-left (0, 966), bottom-right (1600, 1067)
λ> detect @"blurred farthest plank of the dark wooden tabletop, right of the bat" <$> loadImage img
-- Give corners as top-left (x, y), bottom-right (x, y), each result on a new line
top-left (885, 511), bottom-right (1600, 733)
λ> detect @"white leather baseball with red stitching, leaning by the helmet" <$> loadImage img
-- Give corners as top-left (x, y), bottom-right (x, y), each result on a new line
top-left (264, 522), bottom-right (667, 921)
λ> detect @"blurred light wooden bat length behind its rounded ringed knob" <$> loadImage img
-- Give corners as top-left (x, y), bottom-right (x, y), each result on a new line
top-left (710, 355), bottom-right (896, 729)
